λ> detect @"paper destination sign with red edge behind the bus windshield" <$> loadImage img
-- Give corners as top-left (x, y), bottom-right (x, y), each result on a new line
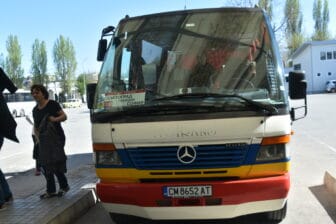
top-left (104, 90), bottom-right (145, 108)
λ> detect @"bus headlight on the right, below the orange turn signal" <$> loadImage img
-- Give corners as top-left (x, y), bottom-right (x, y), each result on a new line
top-left (256, 144), bottom-right (288, 162)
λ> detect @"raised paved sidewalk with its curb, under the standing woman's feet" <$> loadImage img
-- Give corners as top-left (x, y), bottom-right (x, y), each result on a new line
top-left (0, 164), bottom-right (98, 224)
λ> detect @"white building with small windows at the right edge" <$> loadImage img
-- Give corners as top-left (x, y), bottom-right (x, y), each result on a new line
top-left (291, 40), bottom-right (336, 93)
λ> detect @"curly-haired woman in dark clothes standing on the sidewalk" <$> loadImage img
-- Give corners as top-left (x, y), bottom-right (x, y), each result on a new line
top-left (31, 85), bottom-right (69, 199)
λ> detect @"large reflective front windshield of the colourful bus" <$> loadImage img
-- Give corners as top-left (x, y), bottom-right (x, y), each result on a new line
top-left (94, 9), bottom-right (287, 116)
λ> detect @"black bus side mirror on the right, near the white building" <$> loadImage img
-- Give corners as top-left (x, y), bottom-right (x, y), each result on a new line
top-left (288, 71), bottom-right (307, 121)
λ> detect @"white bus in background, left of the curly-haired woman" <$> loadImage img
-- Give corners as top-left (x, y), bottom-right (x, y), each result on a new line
top-left (3, 89), bottom-right (36, 117)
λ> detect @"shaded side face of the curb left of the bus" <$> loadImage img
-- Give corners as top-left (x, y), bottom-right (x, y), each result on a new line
top-left (45, 189), bottom-right (97, 224)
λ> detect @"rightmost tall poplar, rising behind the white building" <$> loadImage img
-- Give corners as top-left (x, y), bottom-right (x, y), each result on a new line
top-left (312, 0), bottom-right (330, 40)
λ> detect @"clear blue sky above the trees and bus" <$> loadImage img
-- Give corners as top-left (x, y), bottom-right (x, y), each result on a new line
top-left (0, 0), bottom-right (336, 76)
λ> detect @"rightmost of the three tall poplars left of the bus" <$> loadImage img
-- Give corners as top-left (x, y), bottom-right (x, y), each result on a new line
top-left (53, 35), bottom-right (77, 95)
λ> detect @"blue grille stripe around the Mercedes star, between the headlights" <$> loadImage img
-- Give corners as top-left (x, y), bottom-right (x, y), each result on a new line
top-left (96, 143), bottom-right (289, 170)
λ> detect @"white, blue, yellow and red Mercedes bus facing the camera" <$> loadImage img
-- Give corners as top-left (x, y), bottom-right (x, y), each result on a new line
top-left (87, 8), bottom-right (307, 224)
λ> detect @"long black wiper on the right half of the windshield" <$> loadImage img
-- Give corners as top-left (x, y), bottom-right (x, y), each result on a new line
top-left (153, 93), bottom-right (278, 115)
